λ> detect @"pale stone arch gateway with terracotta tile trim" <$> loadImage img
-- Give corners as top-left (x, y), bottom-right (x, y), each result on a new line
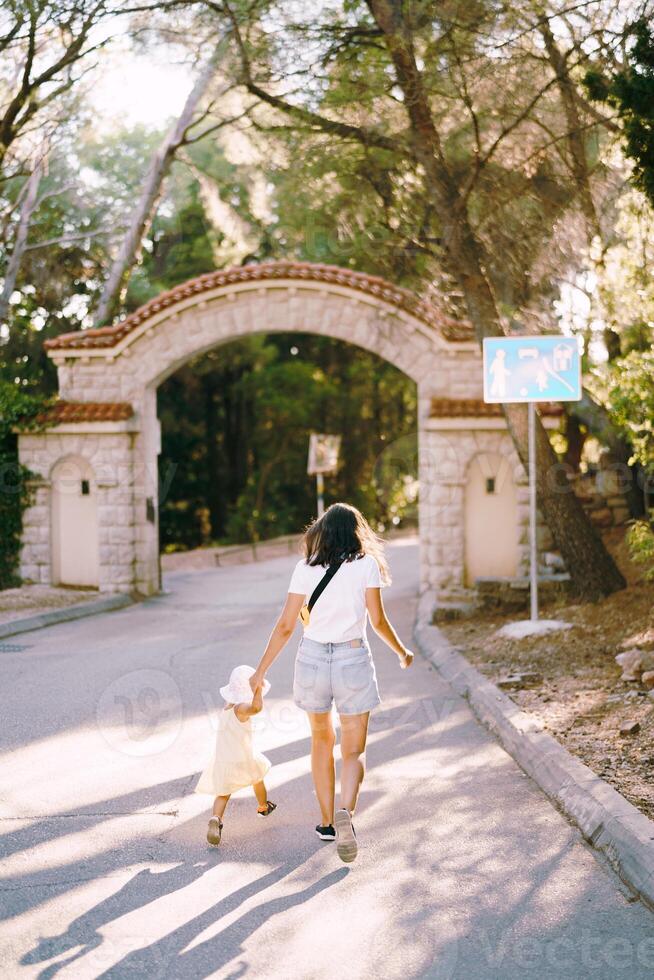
top-left (19, 261), bottom-right (544, 600)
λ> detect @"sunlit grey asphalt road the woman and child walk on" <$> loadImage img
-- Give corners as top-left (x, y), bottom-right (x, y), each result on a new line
top-left (0, 542), bottom-right (654, 980)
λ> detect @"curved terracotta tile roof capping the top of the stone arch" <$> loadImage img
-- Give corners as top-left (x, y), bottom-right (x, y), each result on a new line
top-left (45, 261), bottom-right (474, 350)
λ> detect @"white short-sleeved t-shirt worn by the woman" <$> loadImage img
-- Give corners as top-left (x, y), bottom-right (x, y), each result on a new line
top-left (288, 555), bottom-right (381, 643)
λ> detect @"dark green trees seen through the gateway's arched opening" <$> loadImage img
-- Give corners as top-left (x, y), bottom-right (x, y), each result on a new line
top-left (159, 334), bottom-right (417, 550)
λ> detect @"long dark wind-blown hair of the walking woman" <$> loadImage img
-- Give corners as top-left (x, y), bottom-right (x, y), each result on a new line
top-left (301, 503), bottom-right (391, 585)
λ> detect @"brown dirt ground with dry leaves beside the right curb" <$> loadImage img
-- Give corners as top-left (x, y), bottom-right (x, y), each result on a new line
top-left (439, 529), bottom-right (654, 818)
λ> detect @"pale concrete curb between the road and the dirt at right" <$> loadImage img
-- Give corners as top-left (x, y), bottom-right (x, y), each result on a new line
top-left (414, 615), bottom-right (654, 909)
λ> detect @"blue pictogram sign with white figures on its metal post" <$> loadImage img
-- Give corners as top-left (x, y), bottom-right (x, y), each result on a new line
top-left (484, 334), bottom-right (581, 620)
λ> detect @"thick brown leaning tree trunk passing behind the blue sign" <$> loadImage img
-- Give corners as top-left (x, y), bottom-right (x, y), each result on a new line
top-left (368, 0), bottom-right (625, 600)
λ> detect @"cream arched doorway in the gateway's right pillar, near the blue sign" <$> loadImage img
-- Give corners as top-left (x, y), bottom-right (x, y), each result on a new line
top-left (465, 453), bottom-right (519, 586)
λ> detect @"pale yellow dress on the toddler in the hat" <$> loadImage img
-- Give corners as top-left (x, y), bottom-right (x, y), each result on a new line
top-left (195, 708), bottom-right (272, 796)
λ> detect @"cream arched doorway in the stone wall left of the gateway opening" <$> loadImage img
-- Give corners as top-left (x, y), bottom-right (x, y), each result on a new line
top-left (51, 456), bottom-right (100, 588)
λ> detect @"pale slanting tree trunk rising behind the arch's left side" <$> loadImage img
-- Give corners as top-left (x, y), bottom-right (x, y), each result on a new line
top-left (93, 44), bottom-right (222, 327)
